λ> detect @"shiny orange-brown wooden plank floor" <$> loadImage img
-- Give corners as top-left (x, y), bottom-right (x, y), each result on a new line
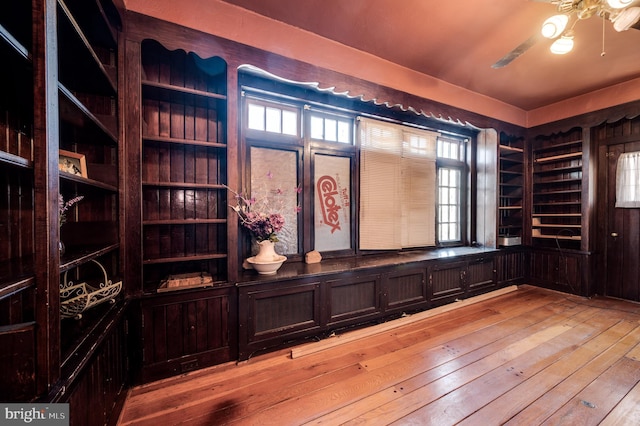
top-left (119, 286), bottom-right (640, 426)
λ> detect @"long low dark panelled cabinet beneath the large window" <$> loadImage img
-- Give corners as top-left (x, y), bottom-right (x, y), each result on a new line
top-left (238, 251), bottom-right (506, 360)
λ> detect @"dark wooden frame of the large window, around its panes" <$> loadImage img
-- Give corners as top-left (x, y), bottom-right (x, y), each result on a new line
top-left (238, 73), bottom-right (478, 261)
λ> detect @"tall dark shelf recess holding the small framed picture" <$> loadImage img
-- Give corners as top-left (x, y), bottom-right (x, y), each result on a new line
top-left (52, 0), bottom-right (122, 390)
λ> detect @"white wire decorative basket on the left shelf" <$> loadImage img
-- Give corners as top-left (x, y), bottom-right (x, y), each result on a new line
top-left (60, 260), bottom-right (122, 319)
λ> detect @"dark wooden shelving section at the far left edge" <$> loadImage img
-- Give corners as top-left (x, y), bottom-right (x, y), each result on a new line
top-left (0, 1), bottom-right (36, 402)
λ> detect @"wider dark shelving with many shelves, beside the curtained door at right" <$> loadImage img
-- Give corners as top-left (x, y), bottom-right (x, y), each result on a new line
top-left (531, 129), bottom-right (583, 249)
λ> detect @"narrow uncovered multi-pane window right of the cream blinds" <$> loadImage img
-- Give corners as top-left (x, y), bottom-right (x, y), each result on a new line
top-left (436, 137), bottom-right (466, 245)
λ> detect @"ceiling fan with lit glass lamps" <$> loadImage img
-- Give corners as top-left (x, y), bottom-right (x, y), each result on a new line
top-left (491, 0), bottom-right (640, 68)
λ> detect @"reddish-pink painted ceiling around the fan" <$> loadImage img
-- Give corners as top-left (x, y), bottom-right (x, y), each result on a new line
top-left (224, 0), bottom-right (640, 111)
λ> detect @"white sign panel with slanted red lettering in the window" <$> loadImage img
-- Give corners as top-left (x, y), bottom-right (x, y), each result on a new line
top-left (314, 154), bottom-right (351, 251)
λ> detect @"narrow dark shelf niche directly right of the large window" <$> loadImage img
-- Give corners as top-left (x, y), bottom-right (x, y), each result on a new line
top-left (498, 134), bottom-right (525, 246)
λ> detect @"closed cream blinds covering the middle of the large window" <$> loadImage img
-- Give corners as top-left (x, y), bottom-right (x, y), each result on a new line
top-left (359, 118), bottom-right (439, 250)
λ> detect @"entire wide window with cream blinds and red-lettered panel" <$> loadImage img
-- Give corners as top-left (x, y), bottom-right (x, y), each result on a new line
top-left (241, 79), bottom-right (472, 259)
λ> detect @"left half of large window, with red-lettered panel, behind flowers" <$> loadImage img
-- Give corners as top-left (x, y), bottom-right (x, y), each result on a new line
top-left (243, 92), bottom-right (357, 256)
